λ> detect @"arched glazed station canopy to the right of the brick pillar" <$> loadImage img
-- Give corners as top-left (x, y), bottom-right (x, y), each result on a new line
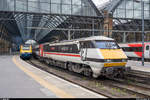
top-left (100, 0), bottom-right (150, 31)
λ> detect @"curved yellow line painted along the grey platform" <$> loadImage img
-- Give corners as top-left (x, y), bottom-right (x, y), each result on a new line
top-left (12, 56), bottom-right (75, 98)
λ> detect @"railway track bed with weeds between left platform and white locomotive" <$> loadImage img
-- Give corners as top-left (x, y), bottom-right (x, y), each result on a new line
top-left (27, 59), bottom-right (150, 98)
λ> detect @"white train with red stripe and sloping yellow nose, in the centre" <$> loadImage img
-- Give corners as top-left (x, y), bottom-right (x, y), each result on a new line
top-left (33, 36), bottom-right (131, 78)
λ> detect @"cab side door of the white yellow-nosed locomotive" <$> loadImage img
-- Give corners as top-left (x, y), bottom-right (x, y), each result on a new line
top-left (80, 42), bottom-right (87, 61)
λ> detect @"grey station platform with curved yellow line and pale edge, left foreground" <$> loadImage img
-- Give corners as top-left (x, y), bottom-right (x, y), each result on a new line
top-left (0, 56), bottom-right (106, 98)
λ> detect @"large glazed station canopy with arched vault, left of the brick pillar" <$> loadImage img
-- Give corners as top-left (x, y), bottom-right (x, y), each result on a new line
top-left (0, 0), bottom-right (101, 41)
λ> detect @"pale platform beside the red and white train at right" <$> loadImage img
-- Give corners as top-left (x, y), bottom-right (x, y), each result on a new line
top-left (127, 60), bottom-right (150, 72)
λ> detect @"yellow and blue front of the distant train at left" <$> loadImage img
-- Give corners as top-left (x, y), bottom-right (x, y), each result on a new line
top-left (20, 45), bottom-right (32, 60)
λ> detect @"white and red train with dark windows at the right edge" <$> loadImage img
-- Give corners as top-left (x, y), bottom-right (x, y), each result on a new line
top-left (119, 42), bottom-right (150, 60)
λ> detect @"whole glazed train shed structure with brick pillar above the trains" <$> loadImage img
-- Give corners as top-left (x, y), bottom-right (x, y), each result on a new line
top-left (0, 0), bottom-right (150, 54)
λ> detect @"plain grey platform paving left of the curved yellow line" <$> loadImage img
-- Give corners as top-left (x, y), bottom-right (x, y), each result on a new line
top-left (0, 56), bottom-right (57, 98)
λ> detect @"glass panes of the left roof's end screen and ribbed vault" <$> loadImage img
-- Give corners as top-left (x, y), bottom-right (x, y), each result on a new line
top-left (0, 0), bottom-right (101, 41)
